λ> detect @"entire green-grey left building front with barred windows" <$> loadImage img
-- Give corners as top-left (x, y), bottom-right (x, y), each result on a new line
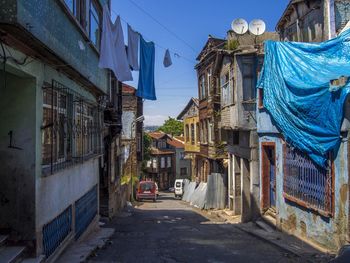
top-left (0, 0), bottom-right (110, 258)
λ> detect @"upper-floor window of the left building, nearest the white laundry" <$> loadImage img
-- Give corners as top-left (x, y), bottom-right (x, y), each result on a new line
top-left (89, 0), bottom-right (101, 49)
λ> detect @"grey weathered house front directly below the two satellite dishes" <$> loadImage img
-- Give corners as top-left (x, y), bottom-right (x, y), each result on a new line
top-left (215, 31), bottom-right (277, 222)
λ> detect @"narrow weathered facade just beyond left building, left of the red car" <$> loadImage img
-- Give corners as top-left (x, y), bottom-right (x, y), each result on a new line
top-left (121, 84), bottom-right (143, 200)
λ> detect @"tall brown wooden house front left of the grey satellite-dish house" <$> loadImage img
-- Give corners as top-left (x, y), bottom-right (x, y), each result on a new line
top-left (195, 36), bottom-right (227, 185)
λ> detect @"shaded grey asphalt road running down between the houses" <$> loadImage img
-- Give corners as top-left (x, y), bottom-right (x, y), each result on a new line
top-left (89, 193), bottom-right (303, 263)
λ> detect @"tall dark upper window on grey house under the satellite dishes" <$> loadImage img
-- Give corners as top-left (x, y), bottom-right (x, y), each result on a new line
top-left (242, 59), bottom-right (256, 101)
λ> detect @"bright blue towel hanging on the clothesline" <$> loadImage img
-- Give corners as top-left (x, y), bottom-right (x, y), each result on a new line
top-left (136, 36), bottom-right (157, 100)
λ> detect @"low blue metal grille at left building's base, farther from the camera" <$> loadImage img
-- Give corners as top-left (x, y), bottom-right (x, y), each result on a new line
top-left (75, 186), bottom-right (97, 239)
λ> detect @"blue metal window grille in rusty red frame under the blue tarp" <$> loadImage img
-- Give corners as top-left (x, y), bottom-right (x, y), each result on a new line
top-left (283, 146), bottom-right (333, 216)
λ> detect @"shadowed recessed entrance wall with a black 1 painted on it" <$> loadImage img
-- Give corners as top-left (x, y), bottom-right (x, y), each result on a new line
top-left (0, 69), bottom-right (36, 240)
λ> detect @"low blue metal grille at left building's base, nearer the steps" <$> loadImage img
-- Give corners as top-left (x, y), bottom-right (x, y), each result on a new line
top-left (43, 206), bottom-right (72, 257)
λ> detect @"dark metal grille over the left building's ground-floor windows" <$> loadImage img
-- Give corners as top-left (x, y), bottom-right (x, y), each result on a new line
top-left (42, 80), bottom-right (103, 174)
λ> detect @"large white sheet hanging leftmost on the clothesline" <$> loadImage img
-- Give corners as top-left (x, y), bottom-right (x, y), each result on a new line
top-left (98, 5), bottom-right (132, 81)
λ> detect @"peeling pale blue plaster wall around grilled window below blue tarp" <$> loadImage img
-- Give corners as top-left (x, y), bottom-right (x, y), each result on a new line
top-left (259, 134), bottom-right (349, 253)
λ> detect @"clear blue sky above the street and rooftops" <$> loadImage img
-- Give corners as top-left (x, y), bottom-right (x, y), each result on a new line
top-left (112, 0), bottom-right (288, 125)
